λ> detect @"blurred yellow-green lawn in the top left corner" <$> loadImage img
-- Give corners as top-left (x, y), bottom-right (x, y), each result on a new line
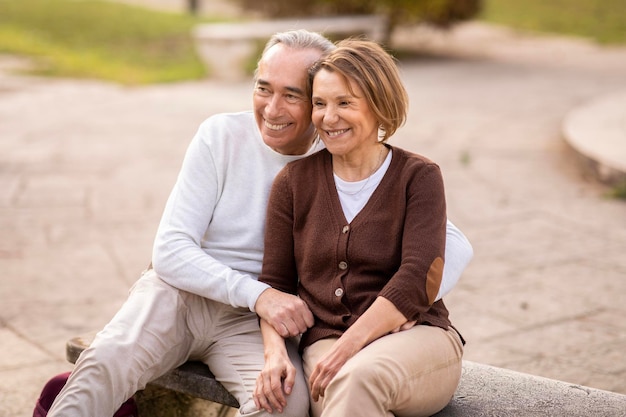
top-left (0, 0), bottom-right (219, 84)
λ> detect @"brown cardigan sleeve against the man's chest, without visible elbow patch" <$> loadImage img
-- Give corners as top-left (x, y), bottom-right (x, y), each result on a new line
top-left (259, 165), bottom-right (298, 294)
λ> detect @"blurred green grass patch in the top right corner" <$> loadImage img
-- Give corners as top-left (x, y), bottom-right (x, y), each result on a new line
top-left (480, 0), bottom-right (626, 45)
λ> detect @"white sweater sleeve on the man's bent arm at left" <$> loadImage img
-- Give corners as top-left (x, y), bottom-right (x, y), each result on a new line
top-left (152, 119), bottom-right (268, 311)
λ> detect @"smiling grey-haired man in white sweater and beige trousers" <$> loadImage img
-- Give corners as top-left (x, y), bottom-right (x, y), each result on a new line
top-left (49, 30), bottom-right (472, 417)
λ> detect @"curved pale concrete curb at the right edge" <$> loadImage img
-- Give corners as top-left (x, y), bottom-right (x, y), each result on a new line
top-left (563, 91), bottom-right (626, 185)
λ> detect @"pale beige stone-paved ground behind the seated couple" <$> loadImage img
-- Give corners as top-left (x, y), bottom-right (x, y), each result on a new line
top-left (0, 13), bottom-right (626, 417)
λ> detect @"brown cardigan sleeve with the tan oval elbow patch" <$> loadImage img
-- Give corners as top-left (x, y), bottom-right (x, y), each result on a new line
top-left (379, 160), bottom-right (446, 321)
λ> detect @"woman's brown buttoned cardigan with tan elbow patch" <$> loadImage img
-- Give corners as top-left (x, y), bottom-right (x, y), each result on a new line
top-left (259, 147), bottom-right (450, 349)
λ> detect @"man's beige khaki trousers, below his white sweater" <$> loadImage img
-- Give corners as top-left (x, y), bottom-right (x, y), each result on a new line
top-left (48, 270), bottom-right (309, 417)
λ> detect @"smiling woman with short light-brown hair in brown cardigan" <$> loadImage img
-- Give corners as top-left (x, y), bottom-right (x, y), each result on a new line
top-left (255, 40), bottom-right (463, 417)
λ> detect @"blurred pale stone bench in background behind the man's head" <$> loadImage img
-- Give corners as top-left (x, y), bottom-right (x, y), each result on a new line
top-left (193, 15), bottom-right (387, 80)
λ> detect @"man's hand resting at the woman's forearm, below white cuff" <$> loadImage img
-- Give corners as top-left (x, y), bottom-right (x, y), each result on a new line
top-left (254, 288), bottom-right (314, 338)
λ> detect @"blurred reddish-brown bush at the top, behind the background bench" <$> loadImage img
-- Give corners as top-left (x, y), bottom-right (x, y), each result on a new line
top-left (228, 0), bottom-right (482, 38)
